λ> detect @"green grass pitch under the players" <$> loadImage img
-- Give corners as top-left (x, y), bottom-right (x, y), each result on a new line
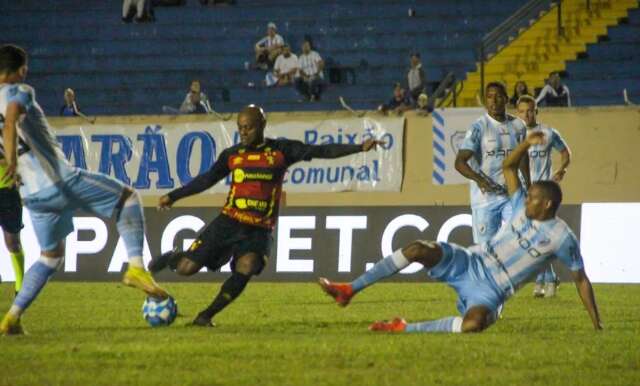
top-left (0, 282), bottom-right (640, 386)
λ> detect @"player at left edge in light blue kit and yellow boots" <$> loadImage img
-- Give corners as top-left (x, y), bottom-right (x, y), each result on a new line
top-left (0, 45), bottom-right (168, 335)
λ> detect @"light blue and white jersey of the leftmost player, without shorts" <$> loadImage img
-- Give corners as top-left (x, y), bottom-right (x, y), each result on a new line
top-left (0, 84), bottom-right (76, 197)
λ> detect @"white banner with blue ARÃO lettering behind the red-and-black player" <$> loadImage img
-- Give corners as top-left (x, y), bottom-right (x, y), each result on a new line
top-left (57, 118), bottom-right (404, 195)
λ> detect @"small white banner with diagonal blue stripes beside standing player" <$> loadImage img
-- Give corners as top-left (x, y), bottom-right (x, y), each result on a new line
top-left (432, 107), bottom-right (485, 185)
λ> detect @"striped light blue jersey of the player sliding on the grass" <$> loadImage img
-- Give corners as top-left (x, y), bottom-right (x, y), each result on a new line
top-left (469, 189), bottom-right (584, 296)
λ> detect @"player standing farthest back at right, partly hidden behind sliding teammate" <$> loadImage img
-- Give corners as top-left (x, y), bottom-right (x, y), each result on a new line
top-left (516, 95), bottom-right (571, 297)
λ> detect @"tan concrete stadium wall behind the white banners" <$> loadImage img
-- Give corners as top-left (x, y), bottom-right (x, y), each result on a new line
top-left (50, 107), bottom-right (640, 206)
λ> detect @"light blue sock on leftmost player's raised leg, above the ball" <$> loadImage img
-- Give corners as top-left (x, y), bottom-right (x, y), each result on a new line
top-left (116, 192), bottom-right (144, 268)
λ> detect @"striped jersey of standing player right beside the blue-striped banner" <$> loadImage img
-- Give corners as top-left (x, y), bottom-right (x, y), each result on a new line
top-left (460, 114), bottom-right (526, 208)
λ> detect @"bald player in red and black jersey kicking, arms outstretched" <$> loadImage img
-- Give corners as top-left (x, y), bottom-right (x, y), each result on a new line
top-left (149, 105), bottom-right (384, 327)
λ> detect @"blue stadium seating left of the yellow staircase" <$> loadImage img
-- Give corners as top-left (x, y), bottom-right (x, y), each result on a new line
top-left (0, 0), bottom-right (528, 115)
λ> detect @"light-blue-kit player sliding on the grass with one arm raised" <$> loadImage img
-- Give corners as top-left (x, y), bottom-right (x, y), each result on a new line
top-left (319, 132), bottom-right (602, 332)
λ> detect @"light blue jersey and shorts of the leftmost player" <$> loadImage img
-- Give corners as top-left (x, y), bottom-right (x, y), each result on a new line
top-left (0, 84), bottom-right (127, 250)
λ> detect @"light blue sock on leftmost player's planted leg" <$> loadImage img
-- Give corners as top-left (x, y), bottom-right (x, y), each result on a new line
top-left (9, 256), bottom-right (64, 316)
